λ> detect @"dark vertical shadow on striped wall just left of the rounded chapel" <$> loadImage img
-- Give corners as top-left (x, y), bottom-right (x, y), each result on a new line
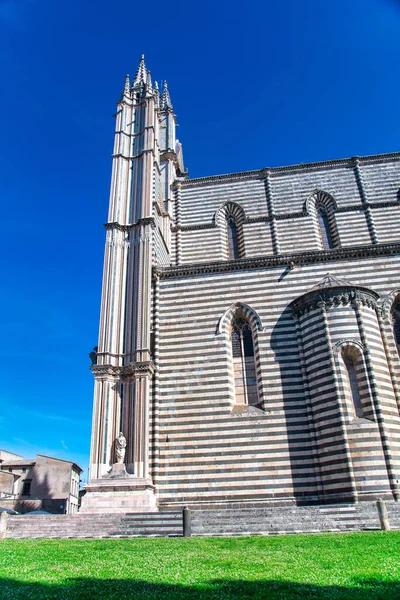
top-left (267, 307), bottom-right (317, 504)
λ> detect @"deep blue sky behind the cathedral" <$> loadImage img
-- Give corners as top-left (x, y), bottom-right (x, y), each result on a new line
top-left (0, 0), bottom-right (400, 478)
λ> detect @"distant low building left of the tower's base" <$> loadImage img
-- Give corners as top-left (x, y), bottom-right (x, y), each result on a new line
top-left (0, 450), bottom-right (82, 514)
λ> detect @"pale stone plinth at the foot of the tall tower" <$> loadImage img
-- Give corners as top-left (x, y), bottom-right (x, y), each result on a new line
top-left (79, 476), bottom-right (157, 514)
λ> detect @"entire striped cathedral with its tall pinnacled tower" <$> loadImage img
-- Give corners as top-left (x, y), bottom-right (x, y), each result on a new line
top-left (82, 58), bottom-right (400, 512)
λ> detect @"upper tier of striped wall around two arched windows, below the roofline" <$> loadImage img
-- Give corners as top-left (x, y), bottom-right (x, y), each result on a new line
top-left (169, 155), bottom-right (400, 264)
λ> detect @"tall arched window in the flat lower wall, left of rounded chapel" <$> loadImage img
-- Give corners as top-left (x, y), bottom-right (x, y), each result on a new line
top-left (231, 317), bottom-right (259, 406)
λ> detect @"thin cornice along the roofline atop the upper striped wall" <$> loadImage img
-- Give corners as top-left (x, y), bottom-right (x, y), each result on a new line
top-left (182, 152), bottom-right (400, 187)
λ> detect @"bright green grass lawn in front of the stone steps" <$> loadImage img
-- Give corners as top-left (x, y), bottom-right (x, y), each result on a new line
top-left (0, 532), bottom-right (400, 600)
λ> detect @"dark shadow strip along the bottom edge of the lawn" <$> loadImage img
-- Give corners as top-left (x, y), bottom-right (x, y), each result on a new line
top-left (0, 578), bottom-right (400, 600)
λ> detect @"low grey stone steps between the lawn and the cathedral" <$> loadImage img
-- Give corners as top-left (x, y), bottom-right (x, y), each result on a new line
top-left (5, 502), bottom-right (400, 538)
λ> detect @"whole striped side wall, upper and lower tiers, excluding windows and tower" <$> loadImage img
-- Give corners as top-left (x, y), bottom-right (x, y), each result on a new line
top-left (151, 155), bottom-right (400, 505)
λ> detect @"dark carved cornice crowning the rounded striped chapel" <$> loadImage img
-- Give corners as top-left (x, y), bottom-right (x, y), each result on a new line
top-left (289, 286), bottom-right (379, 318)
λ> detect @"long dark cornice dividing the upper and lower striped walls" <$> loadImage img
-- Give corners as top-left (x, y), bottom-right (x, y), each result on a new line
top-left (156, 243), bottom-right (400, 278)
